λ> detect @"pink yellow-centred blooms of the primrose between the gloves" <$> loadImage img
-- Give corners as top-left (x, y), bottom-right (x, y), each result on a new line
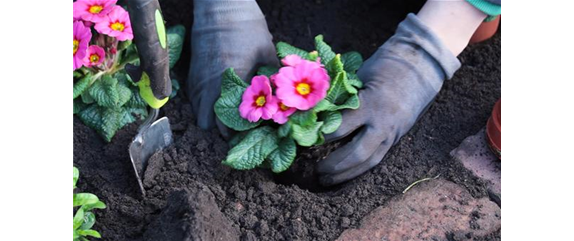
top-left (239, 54), bottom-right (330, 124)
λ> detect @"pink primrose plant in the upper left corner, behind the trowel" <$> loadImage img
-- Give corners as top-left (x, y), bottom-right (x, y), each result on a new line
top-left (73, 0), bottom-right (185, 142)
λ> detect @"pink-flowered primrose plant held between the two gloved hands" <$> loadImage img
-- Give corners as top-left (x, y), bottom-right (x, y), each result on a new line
top-left (215, 35), bottom-right (363, 173)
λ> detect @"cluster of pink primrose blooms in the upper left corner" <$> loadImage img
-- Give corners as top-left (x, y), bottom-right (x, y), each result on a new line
top-left (73, 0), bottom-right (133, 70)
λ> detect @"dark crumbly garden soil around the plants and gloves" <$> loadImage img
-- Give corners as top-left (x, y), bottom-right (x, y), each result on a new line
top-left (73, 0), bottom-right (501, 241)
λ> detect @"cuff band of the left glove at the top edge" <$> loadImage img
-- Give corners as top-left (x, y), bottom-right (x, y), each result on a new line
top-left (193, 0), bottom-right (265, 25)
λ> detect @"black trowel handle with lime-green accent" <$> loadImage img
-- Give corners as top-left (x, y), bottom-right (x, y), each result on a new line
top-left (128, 0), bottom-right (172, 100)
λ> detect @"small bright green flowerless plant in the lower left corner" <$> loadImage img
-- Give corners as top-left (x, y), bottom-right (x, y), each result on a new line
top-left (73, 167), bottom-right (106, 241)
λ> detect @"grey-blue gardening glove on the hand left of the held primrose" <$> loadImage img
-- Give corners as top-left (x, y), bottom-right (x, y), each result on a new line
top-left (187, 0), bottom-right (279, 136)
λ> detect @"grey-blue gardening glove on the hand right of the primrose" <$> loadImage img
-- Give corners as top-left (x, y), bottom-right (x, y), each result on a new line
top-left (317, 14), bottom-right (460, 186)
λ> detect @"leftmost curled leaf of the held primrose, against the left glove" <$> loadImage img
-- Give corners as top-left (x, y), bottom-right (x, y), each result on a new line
top-left (215, 68), bottom-right (261, 131)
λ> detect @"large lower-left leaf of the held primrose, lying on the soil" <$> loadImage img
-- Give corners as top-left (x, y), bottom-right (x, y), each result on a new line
top-left (223, 126), bottom-right (278, 170)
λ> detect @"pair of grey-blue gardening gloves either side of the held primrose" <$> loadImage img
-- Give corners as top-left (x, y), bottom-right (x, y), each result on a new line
top-left (187, 0), bottom-right (460, 186)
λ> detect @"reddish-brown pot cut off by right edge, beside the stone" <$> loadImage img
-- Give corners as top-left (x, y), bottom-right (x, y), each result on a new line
top-left (486, 99), bottom-right (504, 160)
